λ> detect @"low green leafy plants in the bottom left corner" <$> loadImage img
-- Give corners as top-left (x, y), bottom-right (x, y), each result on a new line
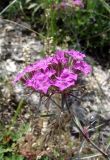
top-left (0, 124), bottom-right (29, 160)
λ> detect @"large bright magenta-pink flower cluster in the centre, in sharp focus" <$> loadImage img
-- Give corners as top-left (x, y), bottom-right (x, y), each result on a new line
top-left (14, 50), bottom-right (91, 94)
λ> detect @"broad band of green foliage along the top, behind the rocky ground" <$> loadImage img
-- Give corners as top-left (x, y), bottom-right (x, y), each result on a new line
top-left (2, 0), bottom-right (110, 56)
